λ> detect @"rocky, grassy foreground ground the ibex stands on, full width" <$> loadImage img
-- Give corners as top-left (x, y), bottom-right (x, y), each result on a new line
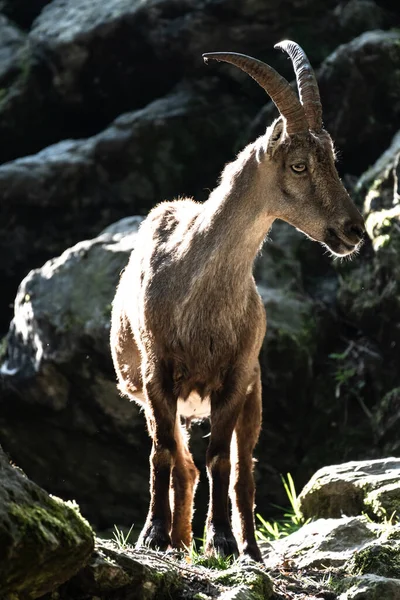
top-left (0, 454), bottom-right (400, 600)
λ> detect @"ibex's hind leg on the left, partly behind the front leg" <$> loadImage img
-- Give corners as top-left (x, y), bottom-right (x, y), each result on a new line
top-left (171, 417), bottom-right (199, 549)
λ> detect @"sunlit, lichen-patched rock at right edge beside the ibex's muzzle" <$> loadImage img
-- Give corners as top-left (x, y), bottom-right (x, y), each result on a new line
top-left (338, 134), bottom-right (400, 418)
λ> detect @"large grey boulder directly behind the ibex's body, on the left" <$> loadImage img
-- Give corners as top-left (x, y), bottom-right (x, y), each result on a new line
top-left (0, 219), bottom-right (150, 529)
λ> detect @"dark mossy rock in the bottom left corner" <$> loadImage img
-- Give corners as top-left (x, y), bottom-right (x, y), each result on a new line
top-left (0, 440), bottom-right (93, 600)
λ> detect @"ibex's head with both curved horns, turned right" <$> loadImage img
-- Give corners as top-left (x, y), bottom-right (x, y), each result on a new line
top-left (203, 40), bottom-right (364, 256)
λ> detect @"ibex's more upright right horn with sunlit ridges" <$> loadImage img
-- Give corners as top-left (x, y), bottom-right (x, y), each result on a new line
top-left (274, 40), bottom-right (322, 132)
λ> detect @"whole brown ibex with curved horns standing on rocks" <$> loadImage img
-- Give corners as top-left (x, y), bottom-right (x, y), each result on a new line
top-left (111, 41), bottom-right (364, 561)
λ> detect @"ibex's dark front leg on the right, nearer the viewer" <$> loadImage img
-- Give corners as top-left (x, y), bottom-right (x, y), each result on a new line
top-left (205, 374), bottom-right (245, 556)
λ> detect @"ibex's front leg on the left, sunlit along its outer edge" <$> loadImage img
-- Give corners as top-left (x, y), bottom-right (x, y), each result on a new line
top-left (138, 363), bottom-right (177, 550)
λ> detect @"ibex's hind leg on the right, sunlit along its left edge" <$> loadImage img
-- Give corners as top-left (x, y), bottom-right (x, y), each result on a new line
top-left (230, 369), bottom-right (262, 562)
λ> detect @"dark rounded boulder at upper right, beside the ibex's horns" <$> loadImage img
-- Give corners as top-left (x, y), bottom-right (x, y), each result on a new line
top-left (318, 31), bottom-right (400, 174)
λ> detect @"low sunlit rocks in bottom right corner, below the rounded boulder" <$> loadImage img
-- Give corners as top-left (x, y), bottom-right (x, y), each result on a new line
top-left (261, 516), bottom-right (400, 600)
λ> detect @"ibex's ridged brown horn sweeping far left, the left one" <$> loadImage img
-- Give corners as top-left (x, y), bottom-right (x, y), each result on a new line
top-left (203, 52), bottom-right (308, 135)
